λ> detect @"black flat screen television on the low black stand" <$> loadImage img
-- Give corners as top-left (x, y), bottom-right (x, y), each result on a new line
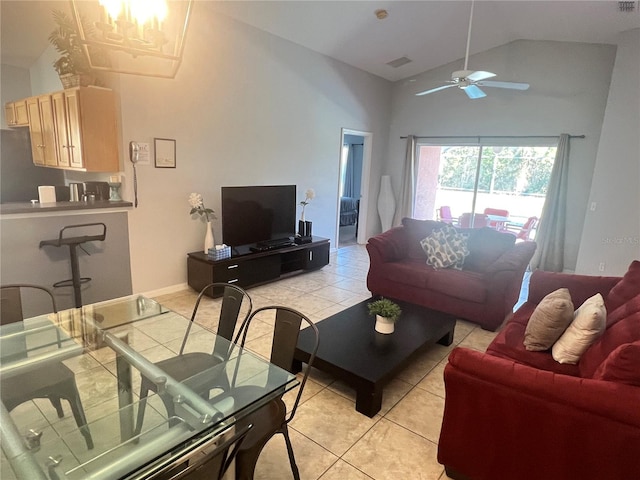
top-left (222, 185), bottom-right (296, 247)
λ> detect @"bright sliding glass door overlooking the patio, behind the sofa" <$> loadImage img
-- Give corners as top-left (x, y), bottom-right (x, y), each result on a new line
top-left (414, 144), bottom-right (556, 238)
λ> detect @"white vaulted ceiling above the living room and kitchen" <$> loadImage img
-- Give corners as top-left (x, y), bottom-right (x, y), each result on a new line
top-left (1, 0), bottom-right (640, 81)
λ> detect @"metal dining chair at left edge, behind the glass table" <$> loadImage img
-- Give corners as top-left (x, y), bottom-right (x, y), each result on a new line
top-left (0, 284), bottom-right (93, 450)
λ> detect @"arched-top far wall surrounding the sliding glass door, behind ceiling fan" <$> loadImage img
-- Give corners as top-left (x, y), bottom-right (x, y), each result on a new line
top-left (384, 40), bottom-right (616, 270)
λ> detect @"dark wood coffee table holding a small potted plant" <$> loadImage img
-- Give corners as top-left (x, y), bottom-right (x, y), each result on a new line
top-left (293, 299), bottom-right (456, 417)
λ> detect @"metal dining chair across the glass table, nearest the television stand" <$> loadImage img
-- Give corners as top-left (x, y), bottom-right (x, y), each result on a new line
top-left (134, 282), bottom-right (253, 435)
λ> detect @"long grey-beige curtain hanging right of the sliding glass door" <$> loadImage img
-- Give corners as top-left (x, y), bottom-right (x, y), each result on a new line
top-left (531, 133), bottom-right (569, 272)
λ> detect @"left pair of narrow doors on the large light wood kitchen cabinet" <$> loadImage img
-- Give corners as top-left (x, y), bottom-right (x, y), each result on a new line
top-left (26, 95), bottom-right (58, 167)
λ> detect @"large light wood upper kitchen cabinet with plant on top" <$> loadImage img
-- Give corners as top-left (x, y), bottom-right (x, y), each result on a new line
top-left (17, 87), bottom-right (120, 172)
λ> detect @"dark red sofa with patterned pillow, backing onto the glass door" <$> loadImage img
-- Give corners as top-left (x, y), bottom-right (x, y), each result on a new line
top-left (367, 218), bottom-right (536, 330)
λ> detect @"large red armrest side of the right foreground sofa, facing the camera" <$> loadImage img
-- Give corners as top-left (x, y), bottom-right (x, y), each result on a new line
top-left (438, 348), bottom-right (640, 480)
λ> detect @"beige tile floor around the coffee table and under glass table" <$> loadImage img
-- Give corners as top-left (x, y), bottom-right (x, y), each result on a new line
top-left (0, 245), bottom-right (504, 480)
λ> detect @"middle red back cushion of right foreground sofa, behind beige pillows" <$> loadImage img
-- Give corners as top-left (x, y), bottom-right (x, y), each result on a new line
top-left (578, 312), bottom-right (640, 378)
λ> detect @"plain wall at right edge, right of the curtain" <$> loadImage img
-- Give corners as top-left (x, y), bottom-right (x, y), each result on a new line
top-left (577, 29), bottom-right (640, 275)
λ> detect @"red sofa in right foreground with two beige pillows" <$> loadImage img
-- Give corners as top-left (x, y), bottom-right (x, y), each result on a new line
top-left (438, 261), bottom-right (640, 480)
